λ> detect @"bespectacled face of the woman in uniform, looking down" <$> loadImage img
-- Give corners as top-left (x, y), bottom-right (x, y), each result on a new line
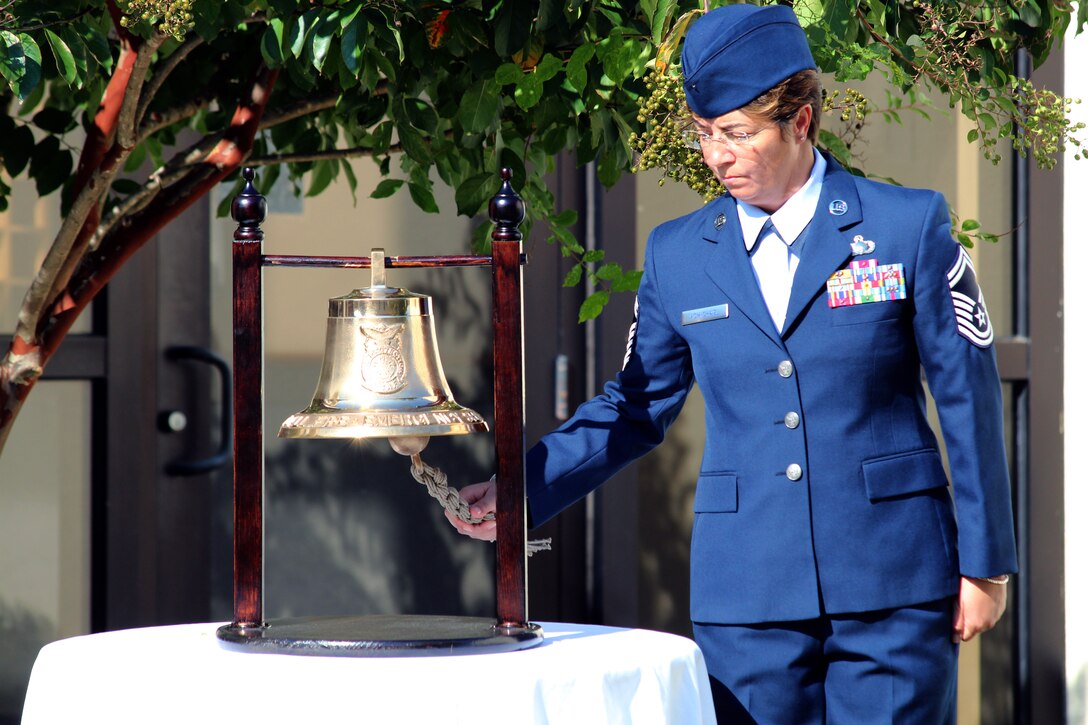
top-left (692, 106), bottom-right (813, 213)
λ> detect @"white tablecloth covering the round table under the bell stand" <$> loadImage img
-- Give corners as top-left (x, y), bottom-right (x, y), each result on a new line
top-left (23, 623), bottom-right (714, 725)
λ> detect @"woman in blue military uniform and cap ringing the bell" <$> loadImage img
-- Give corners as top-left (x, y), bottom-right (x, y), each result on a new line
top-left (453, 4), bottom-right (1016, 725)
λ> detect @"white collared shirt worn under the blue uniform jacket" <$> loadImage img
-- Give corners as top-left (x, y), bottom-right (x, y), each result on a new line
top-left (737, 150), bottom-right (827, 332)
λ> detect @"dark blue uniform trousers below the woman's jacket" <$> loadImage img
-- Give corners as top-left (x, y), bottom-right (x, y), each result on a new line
top-left (694, 599), bottom-right (959, 725)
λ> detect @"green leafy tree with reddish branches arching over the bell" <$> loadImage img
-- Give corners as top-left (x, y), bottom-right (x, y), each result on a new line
top-left (0, 0), bottom-right (1084, 447)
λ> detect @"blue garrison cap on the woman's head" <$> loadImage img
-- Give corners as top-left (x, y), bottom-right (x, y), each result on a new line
top-left (681, 4), bottom-right (816, 119)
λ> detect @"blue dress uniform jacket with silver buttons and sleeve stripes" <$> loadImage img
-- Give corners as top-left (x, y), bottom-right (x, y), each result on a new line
top-left (527, 153), bottom-right (1016, 624)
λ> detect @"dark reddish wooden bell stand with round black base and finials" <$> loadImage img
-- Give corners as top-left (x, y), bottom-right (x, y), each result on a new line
top-left (217, 169), bottom-right (543, 656)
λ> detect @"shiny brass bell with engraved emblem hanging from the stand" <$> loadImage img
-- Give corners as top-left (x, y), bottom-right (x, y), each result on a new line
top-left (280, 249), bottom-right (487, 455)
